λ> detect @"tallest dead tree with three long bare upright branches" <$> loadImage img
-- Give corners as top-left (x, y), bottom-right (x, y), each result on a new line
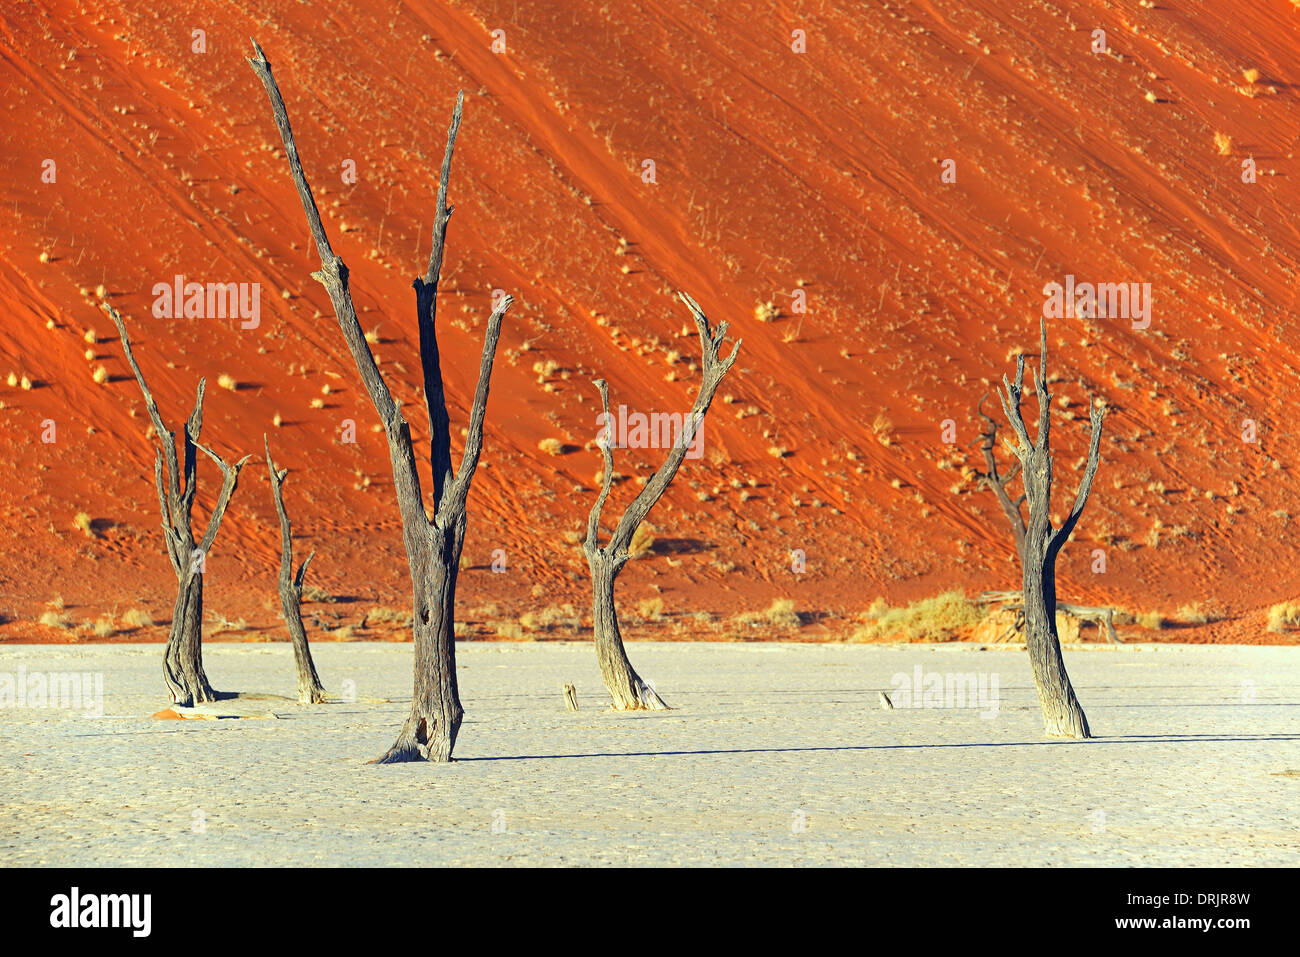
top-left (248, 42), bottom-right (514, 763)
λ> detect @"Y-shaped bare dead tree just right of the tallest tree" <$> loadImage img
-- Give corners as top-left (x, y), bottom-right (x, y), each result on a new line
top-left (582, 293), bottom-right (740, 711)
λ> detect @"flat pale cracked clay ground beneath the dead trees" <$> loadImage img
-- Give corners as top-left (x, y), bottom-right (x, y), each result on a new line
top-left (0, 642), bottom-right (1300, 866)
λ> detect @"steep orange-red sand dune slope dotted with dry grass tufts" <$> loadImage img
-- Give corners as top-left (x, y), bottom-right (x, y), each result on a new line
top-left (0, 0), bottom-right (1300, 641)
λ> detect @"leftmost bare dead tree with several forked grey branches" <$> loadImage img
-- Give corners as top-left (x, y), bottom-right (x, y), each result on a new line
top-left (105, 306), bottom-right (250, 707)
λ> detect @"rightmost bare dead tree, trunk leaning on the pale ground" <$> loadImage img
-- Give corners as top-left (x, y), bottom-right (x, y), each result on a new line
top-left (998, 320), bottom-right (1105, 737)
